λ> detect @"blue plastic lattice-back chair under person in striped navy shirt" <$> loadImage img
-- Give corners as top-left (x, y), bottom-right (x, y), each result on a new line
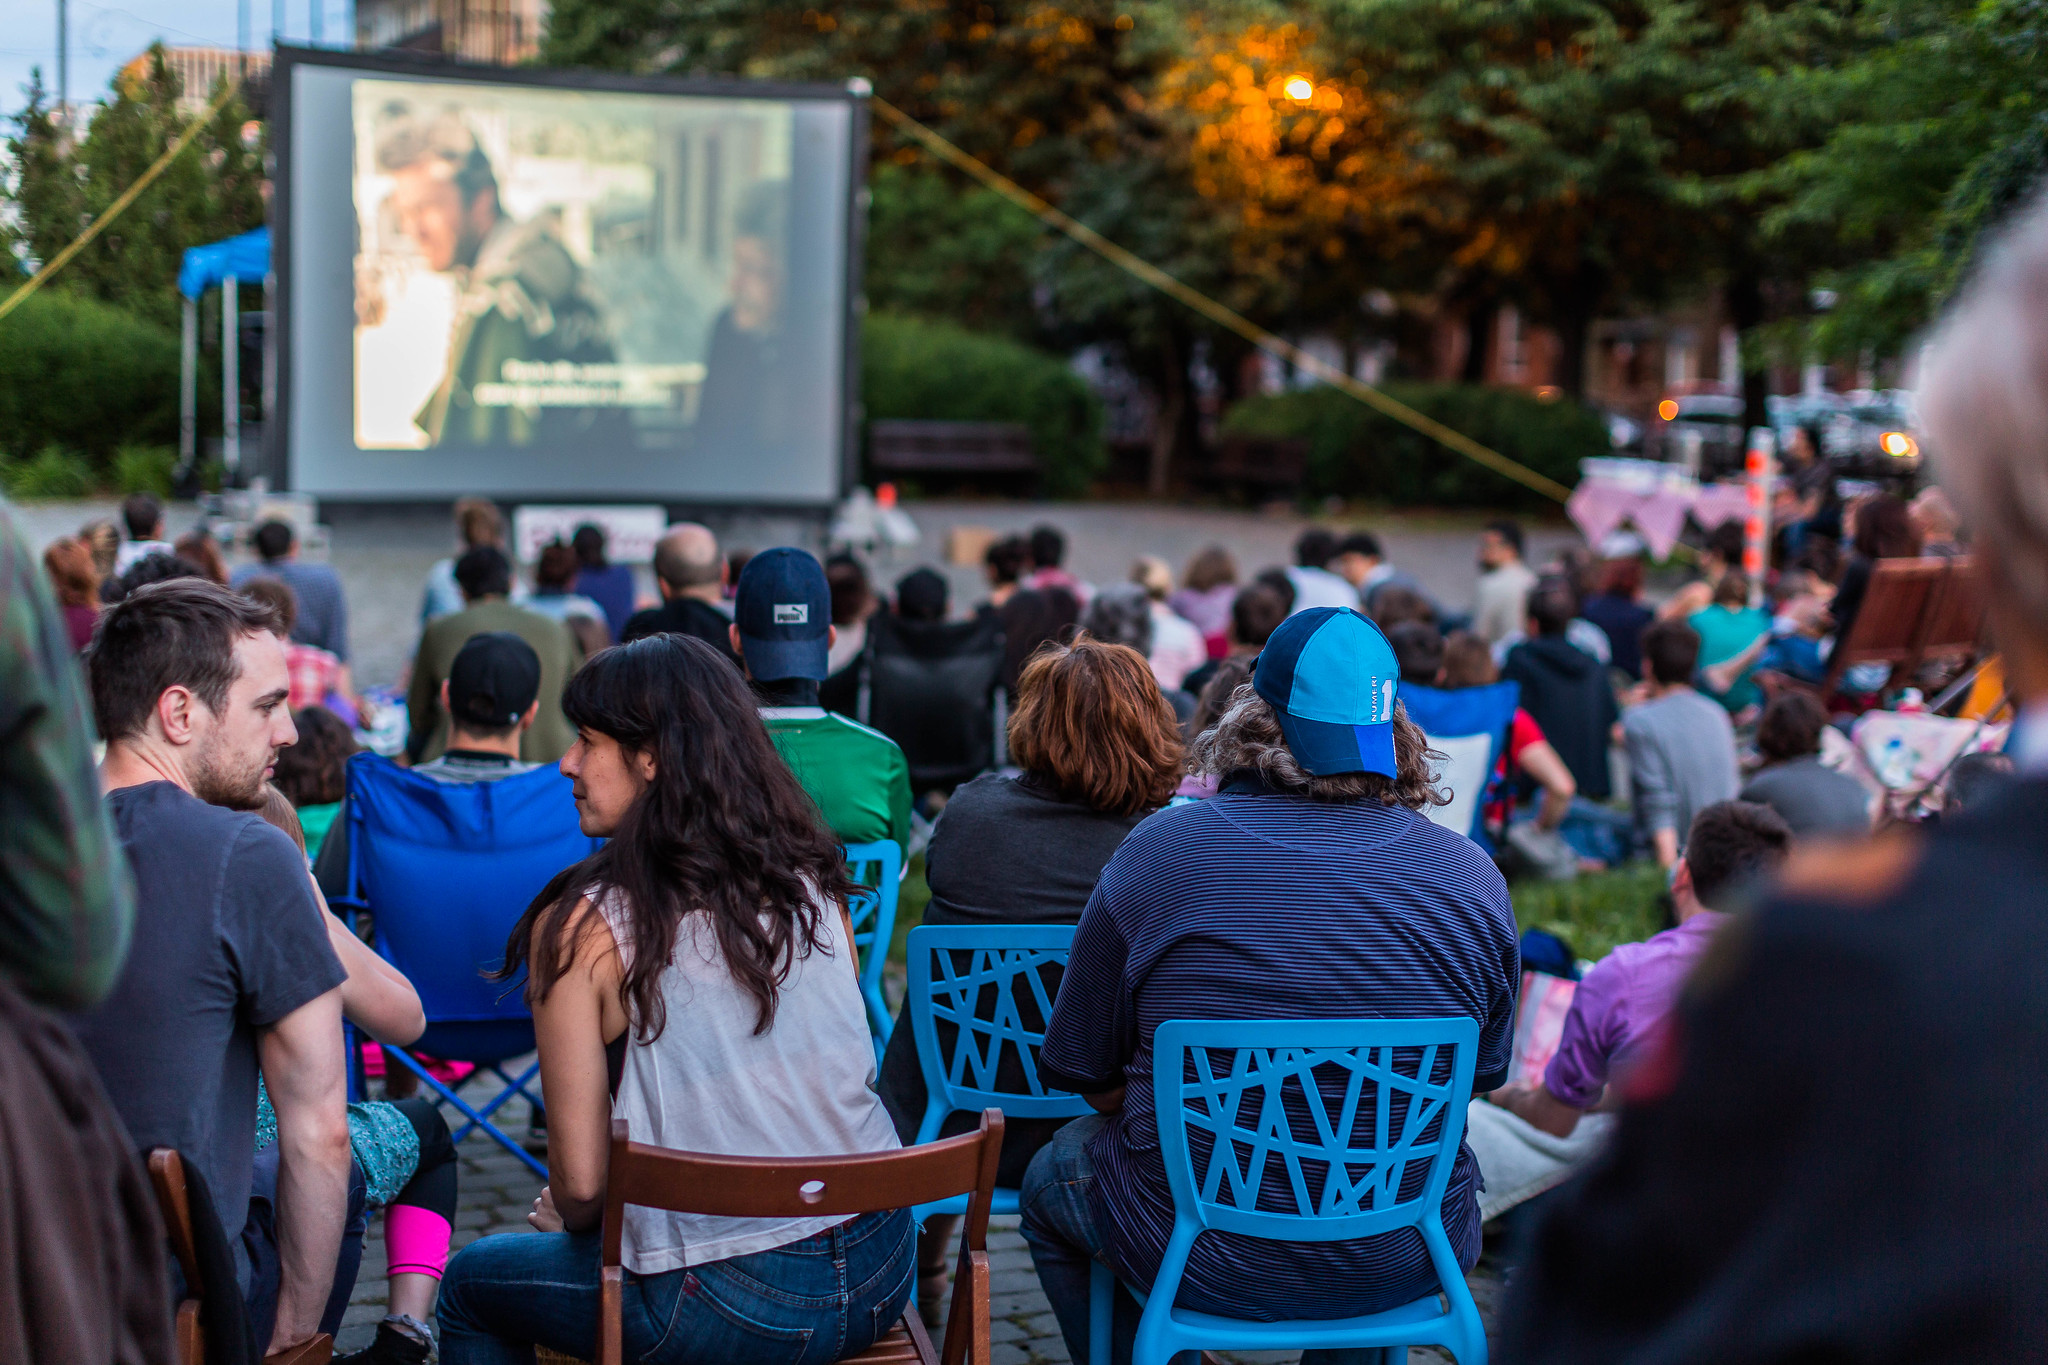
top-left (1090, 1017), bottom-right (1487, 1365)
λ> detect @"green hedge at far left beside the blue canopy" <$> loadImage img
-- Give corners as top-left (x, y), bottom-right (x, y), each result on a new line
top-left (0, 289), bottom-right (192, 473)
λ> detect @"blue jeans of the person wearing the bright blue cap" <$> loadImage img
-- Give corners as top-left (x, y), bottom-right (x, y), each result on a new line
top-left (1018, 1113), bottom-right (1382, 1365)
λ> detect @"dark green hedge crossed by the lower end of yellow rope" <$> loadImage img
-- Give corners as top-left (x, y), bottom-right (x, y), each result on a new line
top-left (1223, 383), bottom-right (1612, 508)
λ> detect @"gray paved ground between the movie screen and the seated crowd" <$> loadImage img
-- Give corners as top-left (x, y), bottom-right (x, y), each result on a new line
top-left (16, 499), bottom-right (1577, 686)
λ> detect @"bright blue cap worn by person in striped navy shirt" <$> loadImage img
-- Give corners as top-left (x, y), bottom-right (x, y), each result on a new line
top-left (1251, 606), bottom-right (1401, 778)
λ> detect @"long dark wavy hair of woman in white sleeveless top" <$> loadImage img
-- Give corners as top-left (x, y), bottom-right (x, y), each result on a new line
top-left (498, 634), bottom-right (856, 1042)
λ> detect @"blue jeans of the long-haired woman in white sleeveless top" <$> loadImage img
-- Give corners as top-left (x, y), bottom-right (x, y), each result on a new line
top-left (436, 1209), bottom-right (918, 1365)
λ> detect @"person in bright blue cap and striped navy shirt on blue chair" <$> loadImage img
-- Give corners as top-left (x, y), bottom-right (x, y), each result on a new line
top-left (1020, 608), bottom-right (1522, 1365)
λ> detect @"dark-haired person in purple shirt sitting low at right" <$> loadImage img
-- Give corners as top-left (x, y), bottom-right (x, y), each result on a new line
top-left (1466, 800), bottom-right (1792, 1218)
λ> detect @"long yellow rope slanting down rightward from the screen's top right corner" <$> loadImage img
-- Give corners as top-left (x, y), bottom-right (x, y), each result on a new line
top-left (870, 94), bottom-right (1571, 501)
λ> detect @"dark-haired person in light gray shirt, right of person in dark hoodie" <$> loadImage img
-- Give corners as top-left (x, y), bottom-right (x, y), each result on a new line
top-left (1622, 620), bottom-right (1741, 868)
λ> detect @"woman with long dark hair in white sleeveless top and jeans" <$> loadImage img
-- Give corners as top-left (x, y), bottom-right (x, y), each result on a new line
top-left (440, 634), bottom-right (915, 1365)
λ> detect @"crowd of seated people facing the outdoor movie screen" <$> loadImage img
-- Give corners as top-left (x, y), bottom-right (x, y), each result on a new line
top-left (8, 376), bottom-right (2025, 1363)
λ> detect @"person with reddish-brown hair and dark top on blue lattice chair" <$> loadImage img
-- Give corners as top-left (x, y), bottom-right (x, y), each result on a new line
top-left (881, 638), bottom-right (1184, 1322)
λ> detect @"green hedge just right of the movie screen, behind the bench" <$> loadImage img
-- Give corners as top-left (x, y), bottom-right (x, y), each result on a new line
top-left (860, 313), bottom-right (1106, 497)
